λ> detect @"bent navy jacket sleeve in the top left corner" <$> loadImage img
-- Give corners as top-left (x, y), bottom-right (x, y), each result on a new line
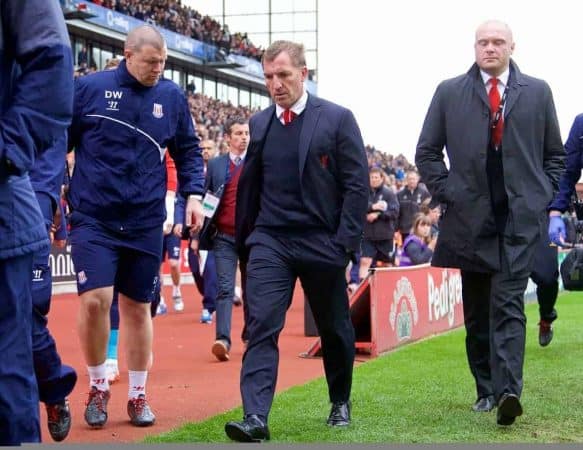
top-left (0, 0), bottom-right (73, 177)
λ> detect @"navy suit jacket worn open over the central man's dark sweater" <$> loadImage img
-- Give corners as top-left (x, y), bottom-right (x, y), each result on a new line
top-left (236, 95), bottom-right (369, 259)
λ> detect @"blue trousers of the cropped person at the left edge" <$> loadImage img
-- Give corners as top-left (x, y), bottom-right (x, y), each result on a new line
top-left (0, 254), bottom-right (40, 446)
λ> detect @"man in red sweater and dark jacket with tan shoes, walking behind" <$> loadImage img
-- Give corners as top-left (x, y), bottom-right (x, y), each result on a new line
top-left (199, 117), bottom-right (249, 361)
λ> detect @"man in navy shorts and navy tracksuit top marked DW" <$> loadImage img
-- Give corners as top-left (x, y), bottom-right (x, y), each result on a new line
top-left (69, 26), bottom-right (204, 428)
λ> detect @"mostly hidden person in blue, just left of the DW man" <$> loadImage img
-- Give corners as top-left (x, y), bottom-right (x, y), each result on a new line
top-left (30, 133), bottom-right (77, 441)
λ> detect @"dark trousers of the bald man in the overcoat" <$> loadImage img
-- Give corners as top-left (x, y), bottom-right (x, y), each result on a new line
top-left (461, 246), bottom-right (530, 401)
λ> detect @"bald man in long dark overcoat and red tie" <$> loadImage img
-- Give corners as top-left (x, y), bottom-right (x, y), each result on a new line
top-left (415, 21), bottom-right (564, 425)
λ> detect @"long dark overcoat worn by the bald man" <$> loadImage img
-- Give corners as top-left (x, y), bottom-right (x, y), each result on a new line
top-left (415, 61), bottom-right (565, 273)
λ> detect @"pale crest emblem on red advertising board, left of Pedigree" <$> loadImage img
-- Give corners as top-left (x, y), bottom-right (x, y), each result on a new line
top-left (389, 277), bottom-right (419, 341)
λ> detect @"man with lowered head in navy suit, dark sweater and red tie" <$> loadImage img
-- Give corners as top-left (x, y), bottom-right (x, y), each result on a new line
top-left (225, 41), bottom-right (368, 442)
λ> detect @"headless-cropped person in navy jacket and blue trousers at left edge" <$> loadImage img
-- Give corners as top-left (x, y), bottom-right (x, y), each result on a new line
top-left (0, 0), bottom-right (73, 446)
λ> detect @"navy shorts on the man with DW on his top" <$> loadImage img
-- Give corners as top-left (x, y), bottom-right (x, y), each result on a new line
top-left (70, 212), bottom-right (162, 303)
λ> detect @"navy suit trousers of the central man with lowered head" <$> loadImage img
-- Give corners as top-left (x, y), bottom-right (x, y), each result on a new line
top-left (241, 230), bottom-right (355, 419)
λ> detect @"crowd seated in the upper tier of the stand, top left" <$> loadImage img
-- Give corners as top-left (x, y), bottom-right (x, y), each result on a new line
top-left (91, 0), bottom-right (263, 61)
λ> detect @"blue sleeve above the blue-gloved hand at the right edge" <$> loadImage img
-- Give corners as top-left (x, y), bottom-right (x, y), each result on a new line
top-left (548, 114), bottom-right (583, 212)
